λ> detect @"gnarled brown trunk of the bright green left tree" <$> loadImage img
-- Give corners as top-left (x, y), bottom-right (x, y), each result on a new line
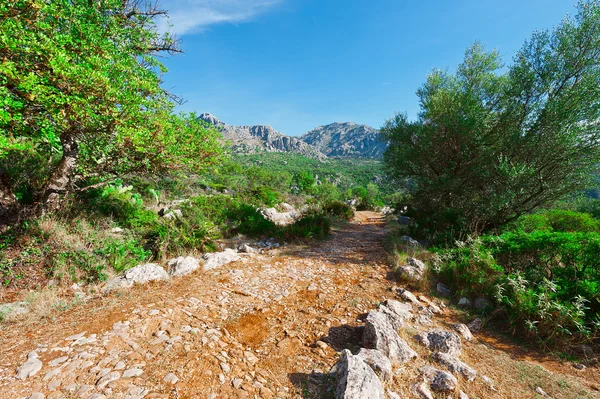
top-left (44, 131), bottom-right (79, 208)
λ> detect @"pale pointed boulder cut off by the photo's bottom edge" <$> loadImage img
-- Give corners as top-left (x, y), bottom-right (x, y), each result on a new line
top-left (335, 349), bottom-right (385, 399)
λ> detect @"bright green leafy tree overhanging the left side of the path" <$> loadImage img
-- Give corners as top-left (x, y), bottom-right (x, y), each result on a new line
top-left (0, 0), bottom-right (221, 214)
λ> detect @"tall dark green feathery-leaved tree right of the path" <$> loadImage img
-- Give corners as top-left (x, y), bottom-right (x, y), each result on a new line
top-left (383, 0), bottom-right (600, 239)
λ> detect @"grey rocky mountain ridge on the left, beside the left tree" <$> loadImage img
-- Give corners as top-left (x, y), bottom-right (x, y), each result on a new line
top-left (200, 113), bottom-right (326, 159)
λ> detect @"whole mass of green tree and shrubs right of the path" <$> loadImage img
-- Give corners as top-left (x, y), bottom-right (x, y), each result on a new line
top-left (383, 0), bottom-right (600, 347)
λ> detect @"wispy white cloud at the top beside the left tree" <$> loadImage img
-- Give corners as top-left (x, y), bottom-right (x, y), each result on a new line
top-left (159, 0), bottom-right (284, 36)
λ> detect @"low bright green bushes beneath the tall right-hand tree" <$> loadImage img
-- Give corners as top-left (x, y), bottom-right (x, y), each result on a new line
top-left (436, 210), bottom-right (600, 346)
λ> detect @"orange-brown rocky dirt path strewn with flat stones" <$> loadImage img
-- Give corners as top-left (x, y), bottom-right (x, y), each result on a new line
top-left (0, 212), bottom-right (600, 399)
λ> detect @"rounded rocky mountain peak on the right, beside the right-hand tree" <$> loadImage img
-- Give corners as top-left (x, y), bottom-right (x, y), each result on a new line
top-left (299, 122), bottom-right (387, 158)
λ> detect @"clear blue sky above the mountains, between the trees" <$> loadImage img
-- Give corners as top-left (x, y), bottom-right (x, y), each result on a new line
top-left (162, 0), bottom-right (575, 135)
